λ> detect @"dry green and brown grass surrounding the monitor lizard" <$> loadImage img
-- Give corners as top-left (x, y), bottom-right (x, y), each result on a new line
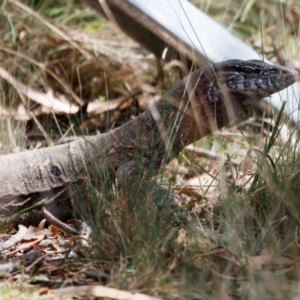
top-left (0, 0), bottom-right (300, 299)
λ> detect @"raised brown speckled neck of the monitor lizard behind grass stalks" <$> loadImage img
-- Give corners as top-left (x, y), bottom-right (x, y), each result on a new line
top-left (110, 69), bottom-right (251, 168)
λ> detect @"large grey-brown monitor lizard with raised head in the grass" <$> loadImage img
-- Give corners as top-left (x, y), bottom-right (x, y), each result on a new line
top-left (0, 60), bottom-right (296, 225)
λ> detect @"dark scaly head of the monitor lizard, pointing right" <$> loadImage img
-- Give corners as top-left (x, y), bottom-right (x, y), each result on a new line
top-left (208, 60), bottom-right (297, 105)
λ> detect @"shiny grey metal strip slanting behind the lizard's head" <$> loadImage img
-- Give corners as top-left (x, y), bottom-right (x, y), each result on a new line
top-left (83, 0), bottom-right (300, 123)
